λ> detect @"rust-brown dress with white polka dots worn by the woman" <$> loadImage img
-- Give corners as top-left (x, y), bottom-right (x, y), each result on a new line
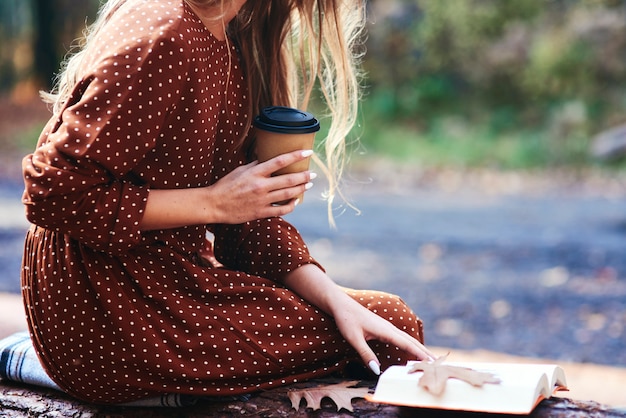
top-left (22, 0), bottom-right (422, 403)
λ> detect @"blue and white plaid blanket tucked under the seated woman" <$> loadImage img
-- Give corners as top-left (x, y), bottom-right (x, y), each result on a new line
top-left (0, 331), bottom-right (198, 407)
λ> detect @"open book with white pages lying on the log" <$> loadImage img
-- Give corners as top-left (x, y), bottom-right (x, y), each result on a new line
top-left (367, 362), bottom-right (567, 414)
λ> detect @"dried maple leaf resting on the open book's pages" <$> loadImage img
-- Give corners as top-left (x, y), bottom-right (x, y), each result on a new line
top-left (409, 356), bottom-right (500, 396)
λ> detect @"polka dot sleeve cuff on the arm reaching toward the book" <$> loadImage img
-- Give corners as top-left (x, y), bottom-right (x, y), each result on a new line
top-left (213, 218), bottom-right (324, 282)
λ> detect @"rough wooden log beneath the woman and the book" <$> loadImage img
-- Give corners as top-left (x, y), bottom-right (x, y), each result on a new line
top-left (0, 380), bottom-right (626, 418)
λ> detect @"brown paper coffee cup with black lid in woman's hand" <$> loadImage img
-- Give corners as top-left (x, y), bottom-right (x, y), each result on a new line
top-left (253, 106), bottom-right (320, 204)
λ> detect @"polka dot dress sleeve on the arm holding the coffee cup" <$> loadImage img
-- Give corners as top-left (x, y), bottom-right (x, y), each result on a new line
top-left (22, 32), bottom-right (186, 252)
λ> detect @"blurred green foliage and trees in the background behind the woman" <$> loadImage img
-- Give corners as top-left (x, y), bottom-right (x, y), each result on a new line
top-left (0, 0), bottom-right (626, 170)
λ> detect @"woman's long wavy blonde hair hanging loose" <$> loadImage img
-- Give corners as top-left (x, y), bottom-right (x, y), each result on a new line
top-left (43, 0), bottom-right (365, 224)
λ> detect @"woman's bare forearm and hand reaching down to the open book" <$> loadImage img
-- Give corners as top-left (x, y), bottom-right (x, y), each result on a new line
top-left (284, 264), bottom-right (437, 374)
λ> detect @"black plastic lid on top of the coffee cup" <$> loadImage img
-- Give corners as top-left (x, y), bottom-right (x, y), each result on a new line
top-left (254, 106), bottom-right (320, 134)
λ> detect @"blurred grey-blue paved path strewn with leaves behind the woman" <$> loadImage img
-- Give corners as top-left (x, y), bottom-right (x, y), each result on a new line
top-left (282, 180), bottom-right (626, 366)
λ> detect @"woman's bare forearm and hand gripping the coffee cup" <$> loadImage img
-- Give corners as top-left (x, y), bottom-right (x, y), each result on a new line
top-left (141, 150), bottom-right (315, 230)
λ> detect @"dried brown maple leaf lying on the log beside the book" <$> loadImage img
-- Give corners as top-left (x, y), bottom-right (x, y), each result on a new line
top-left (289, 380), bottom-right (369, 412)
